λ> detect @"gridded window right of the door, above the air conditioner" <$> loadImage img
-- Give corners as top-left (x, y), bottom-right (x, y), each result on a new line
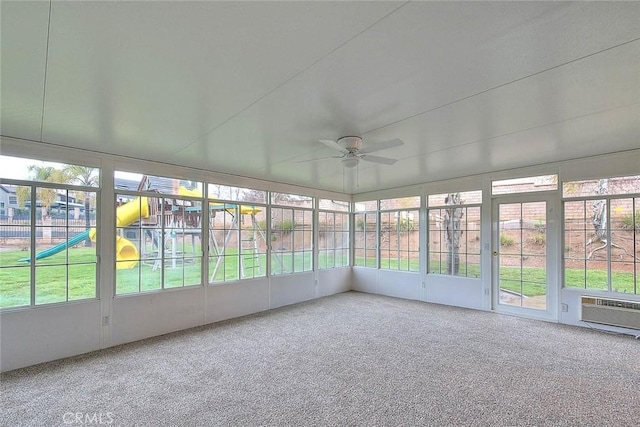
top-left (562, 176), bottom-right (640, 295)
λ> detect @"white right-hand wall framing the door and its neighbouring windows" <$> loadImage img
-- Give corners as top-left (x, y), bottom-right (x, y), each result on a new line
top-left (353, 150), bottom-right (640, 335)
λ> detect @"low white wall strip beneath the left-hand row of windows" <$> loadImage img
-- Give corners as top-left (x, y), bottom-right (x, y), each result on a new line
top-left (0, 268), bottom-right (350, 372)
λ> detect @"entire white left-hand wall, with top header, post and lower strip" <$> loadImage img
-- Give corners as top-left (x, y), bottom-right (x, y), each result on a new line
top-left (0, 137), bottom-right (351, 371)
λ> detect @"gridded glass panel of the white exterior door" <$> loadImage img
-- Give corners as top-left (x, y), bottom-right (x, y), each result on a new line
top-left (498, 202), bottom-right (547, 310)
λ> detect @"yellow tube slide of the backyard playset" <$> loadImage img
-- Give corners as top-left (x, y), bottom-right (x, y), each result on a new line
top-left (89, 197), bottom-right (149, 269)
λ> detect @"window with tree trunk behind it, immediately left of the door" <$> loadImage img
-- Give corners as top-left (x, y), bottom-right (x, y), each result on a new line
top-left (427, 190), bottom-right (482, 278)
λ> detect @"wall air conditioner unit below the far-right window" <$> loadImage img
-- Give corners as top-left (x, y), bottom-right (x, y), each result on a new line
top-left (581, 297), bottom-right (640, 330)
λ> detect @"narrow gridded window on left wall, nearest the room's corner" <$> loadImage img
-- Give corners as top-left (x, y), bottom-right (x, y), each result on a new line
top-left (318, 211), bottom-right (349, 269)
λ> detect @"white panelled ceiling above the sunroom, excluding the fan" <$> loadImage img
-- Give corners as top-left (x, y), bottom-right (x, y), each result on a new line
top-left (1, 1), bottom-right (640, 193)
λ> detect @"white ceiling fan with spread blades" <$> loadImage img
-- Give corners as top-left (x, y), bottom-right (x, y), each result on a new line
top-left (303, 136), bottom-right (404, 168)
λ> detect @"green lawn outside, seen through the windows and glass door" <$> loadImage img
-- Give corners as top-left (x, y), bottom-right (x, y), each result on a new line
top-left (0, 247), bottom-right (640, 307)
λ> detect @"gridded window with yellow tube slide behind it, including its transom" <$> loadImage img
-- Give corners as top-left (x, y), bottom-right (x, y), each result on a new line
top-left (115, 172), bottom-right (202, 294)
